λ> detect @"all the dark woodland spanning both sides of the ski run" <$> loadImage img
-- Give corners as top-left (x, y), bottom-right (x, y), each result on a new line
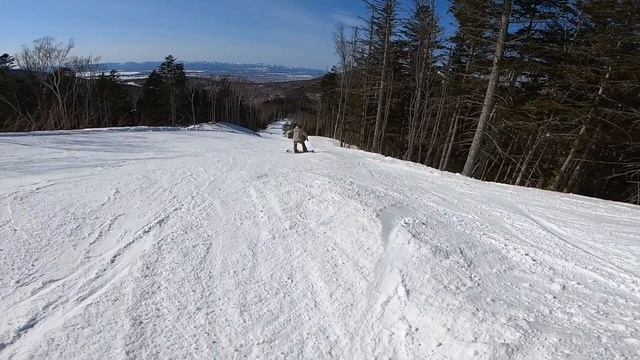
top-left (0, 0), bottom-right (640, 204)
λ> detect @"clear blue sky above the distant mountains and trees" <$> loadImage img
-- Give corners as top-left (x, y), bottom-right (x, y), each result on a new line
top-left (0, 0), bottom-right (451, 69)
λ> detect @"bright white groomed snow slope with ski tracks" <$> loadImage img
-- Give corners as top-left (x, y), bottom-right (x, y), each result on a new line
top-left (0, 122), bottom-right (640, 359)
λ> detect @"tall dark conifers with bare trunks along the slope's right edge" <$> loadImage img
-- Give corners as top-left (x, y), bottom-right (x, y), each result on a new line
top-left (304, 0), bottom-right (640, 204)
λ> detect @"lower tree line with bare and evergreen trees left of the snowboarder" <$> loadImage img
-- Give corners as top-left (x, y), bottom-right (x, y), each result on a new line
top-left (0, 37), bottom-right (260, 131)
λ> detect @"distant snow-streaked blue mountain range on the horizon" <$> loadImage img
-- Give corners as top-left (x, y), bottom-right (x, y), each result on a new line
top-left (101, 61), bottom-right (326, 82)
